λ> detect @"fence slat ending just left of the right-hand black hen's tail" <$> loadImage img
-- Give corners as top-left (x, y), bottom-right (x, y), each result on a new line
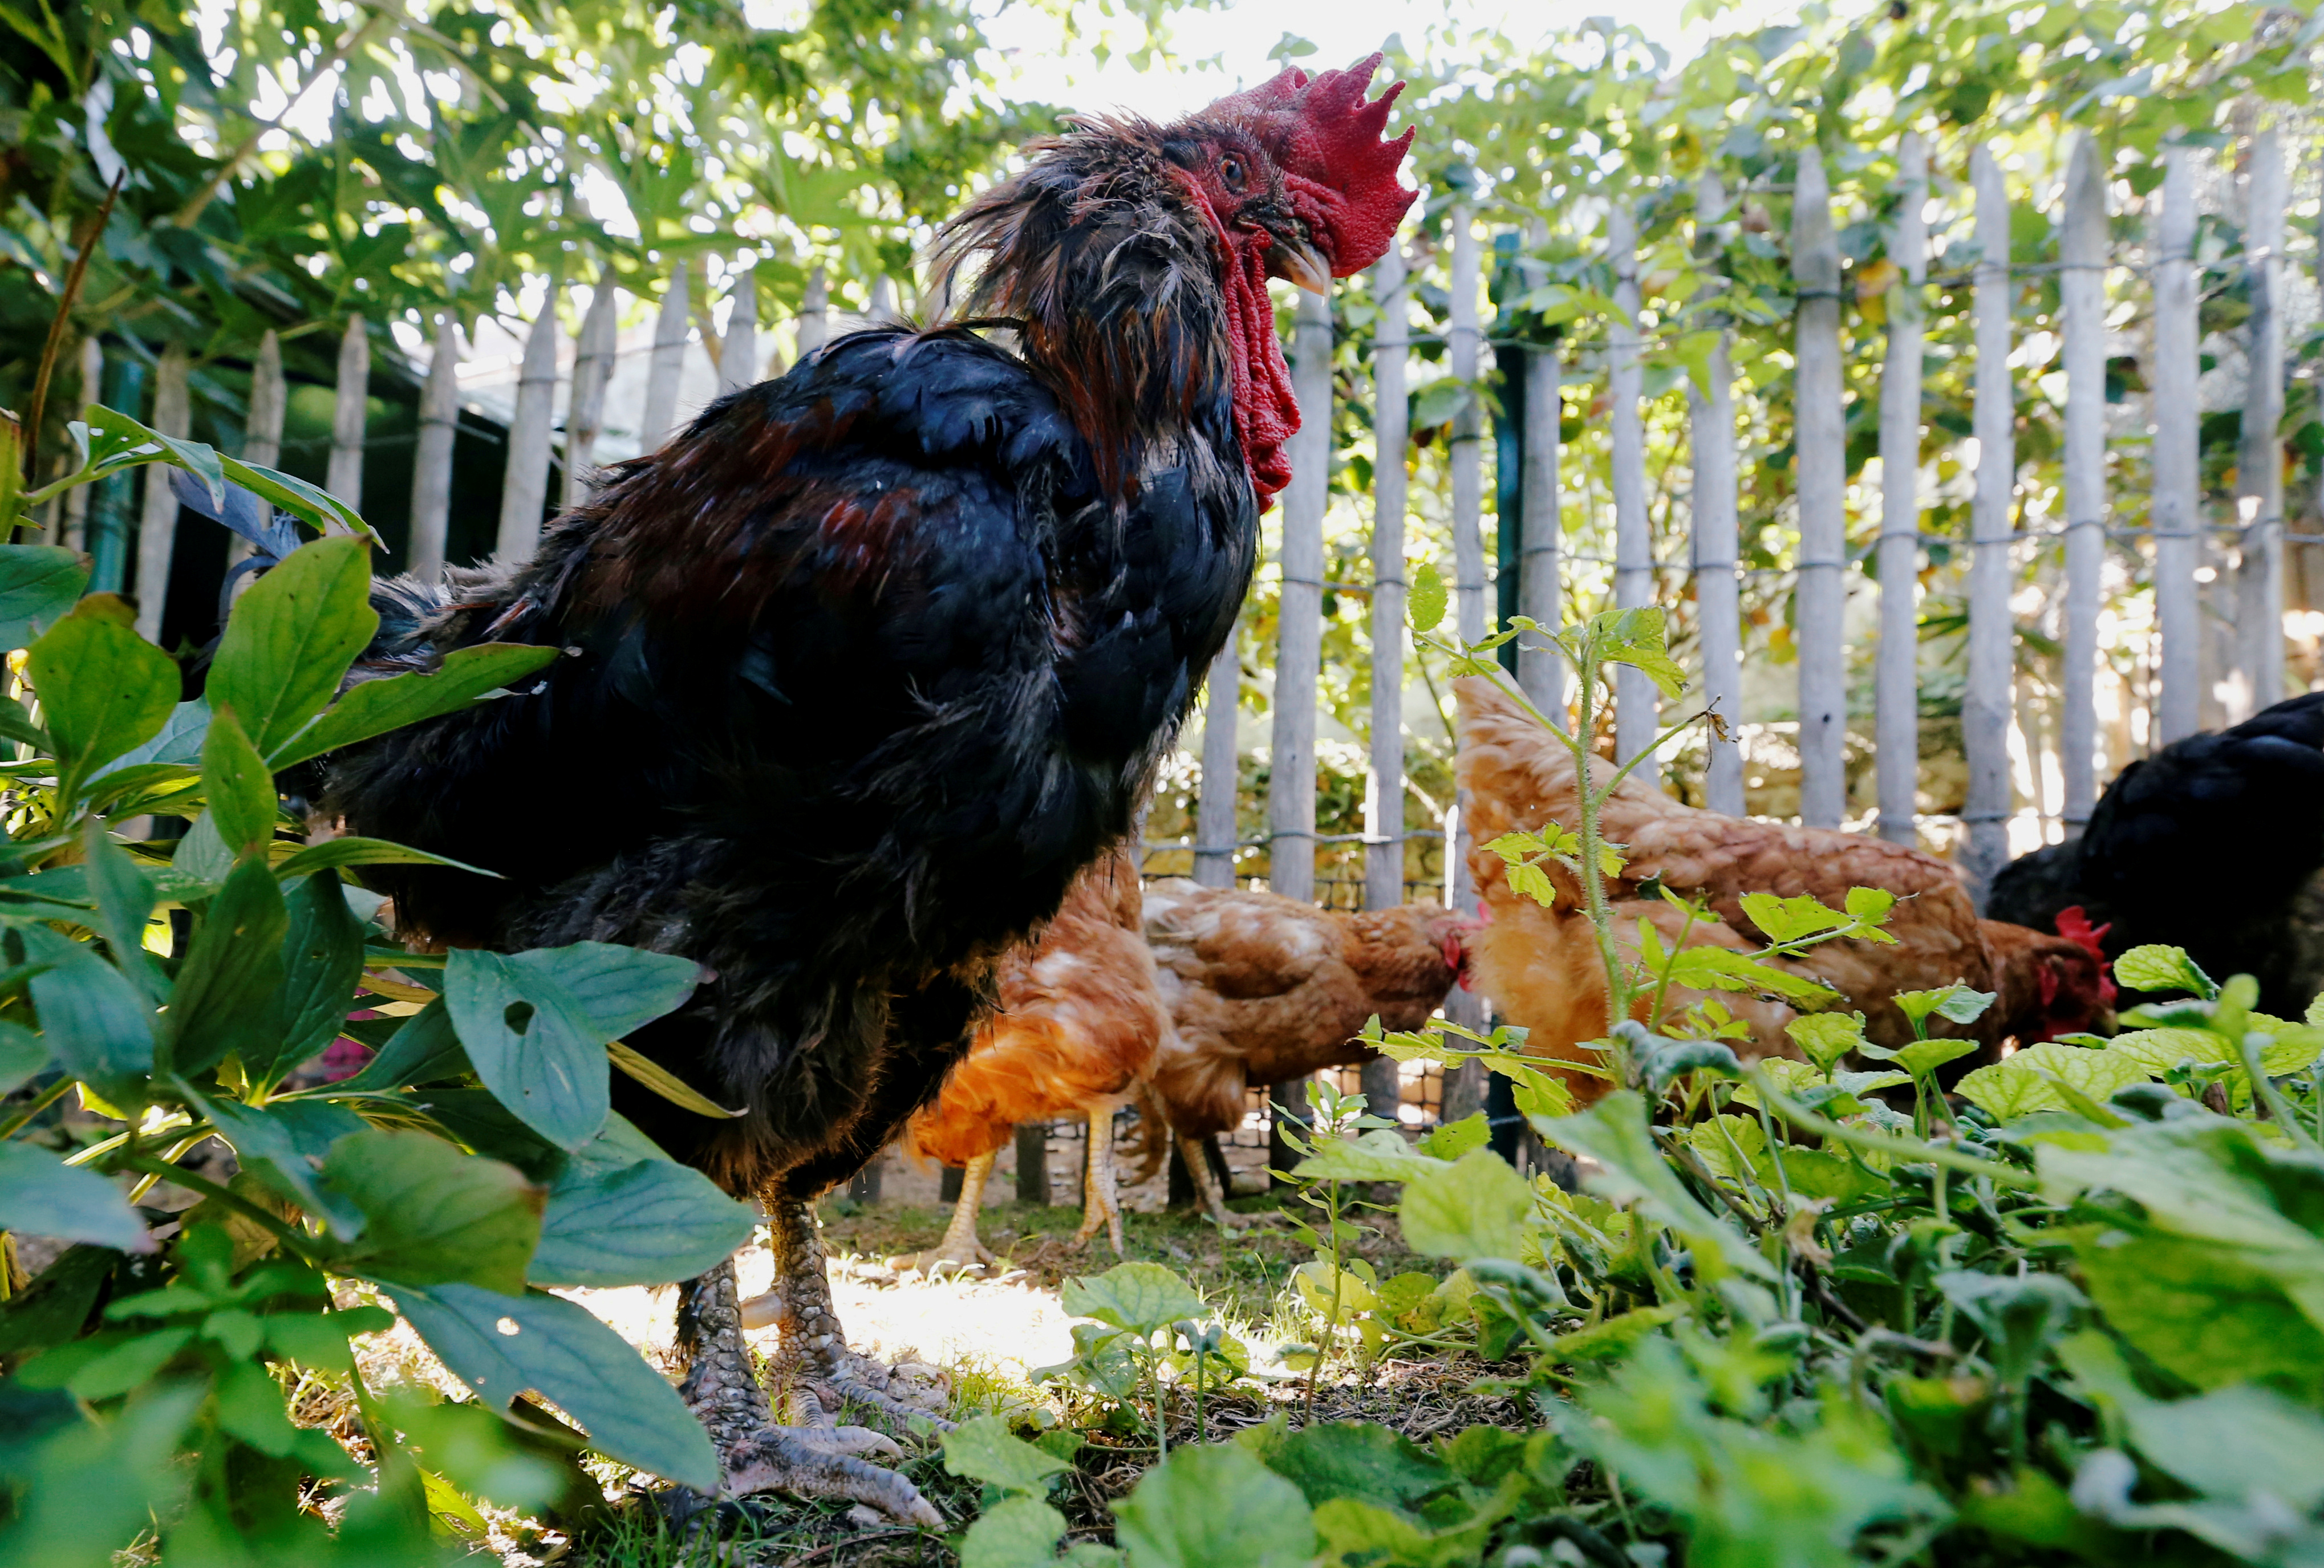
top-left (1961, 147), bottom-right (2017, 906)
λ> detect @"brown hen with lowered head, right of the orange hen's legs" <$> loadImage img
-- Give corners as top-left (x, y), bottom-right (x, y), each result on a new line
top-left (1146, 880), bottom-right (1462, 1224)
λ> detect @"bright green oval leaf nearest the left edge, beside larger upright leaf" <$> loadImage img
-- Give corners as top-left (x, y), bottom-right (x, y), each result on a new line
top-left (26, 595), bottom-right (179, 799)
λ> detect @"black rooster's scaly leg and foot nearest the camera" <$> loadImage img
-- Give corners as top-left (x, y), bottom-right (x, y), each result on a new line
top-left (679, 1259), bottom-right (943, 1529)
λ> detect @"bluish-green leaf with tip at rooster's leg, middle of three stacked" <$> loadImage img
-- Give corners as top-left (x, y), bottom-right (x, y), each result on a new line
top-left (528, 1159), bottom-right (757, 1285)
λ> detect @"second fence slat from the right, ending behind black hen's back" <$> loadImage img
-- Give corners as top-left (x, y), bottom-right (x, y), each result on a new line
top-left (2152, 144), bottom-right (2203, 744)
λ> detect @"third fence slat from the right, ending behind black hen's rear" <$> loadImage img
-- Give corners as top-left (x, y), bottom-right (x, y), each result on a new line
top-left (2057, 132), bottom-right (2108, 836)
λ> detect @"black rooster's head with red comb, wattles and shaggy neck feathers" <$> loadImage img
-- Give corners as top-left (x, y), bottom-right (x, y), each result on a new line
top-left (939, 54), bottom-right (1420, 506)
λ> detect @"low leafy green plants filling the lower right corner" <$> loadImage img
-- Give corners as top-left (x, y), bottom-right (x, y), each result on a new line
top-left (1013, 611), bottom-right (2324, 1568)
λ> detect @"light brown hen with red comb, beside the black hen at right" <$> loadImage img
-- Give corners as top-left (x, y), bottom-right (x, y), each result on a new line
top-left (1455, 676), bottom-right (2106, 1099)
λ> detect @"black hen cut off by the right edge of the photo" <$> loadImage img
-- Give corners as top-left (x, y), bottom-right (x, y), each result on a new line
top-left (1985, 692), bottom-right (2324, 1017)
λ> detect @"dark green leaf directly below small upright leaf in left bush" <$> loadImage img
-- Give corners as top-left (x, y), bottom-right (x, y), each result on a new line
top-left (156, 855), bottom-right (290, 1078)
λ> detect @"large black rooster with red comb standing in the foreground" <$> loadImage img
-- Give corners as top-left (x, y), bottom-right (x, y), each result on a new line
top-left (328, 56), bottom-right (1416, 1524)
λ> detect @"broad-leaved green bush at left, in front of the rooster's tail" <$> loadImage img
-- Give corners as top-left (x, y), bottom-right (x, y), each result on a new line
top-left (0, 409), bottom-right (753, 1568)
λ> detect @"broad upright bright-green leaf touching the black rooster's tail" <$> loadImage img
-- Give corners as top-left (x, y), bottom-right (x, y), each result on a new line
top-left (209, 534), bottom-right (379, 766)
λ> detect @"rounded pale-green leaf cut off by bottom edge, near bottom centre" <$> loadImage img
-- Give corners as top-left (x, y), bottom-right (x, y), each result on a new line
top-left (1113, 1443), bottom-right (1315, 1568)
